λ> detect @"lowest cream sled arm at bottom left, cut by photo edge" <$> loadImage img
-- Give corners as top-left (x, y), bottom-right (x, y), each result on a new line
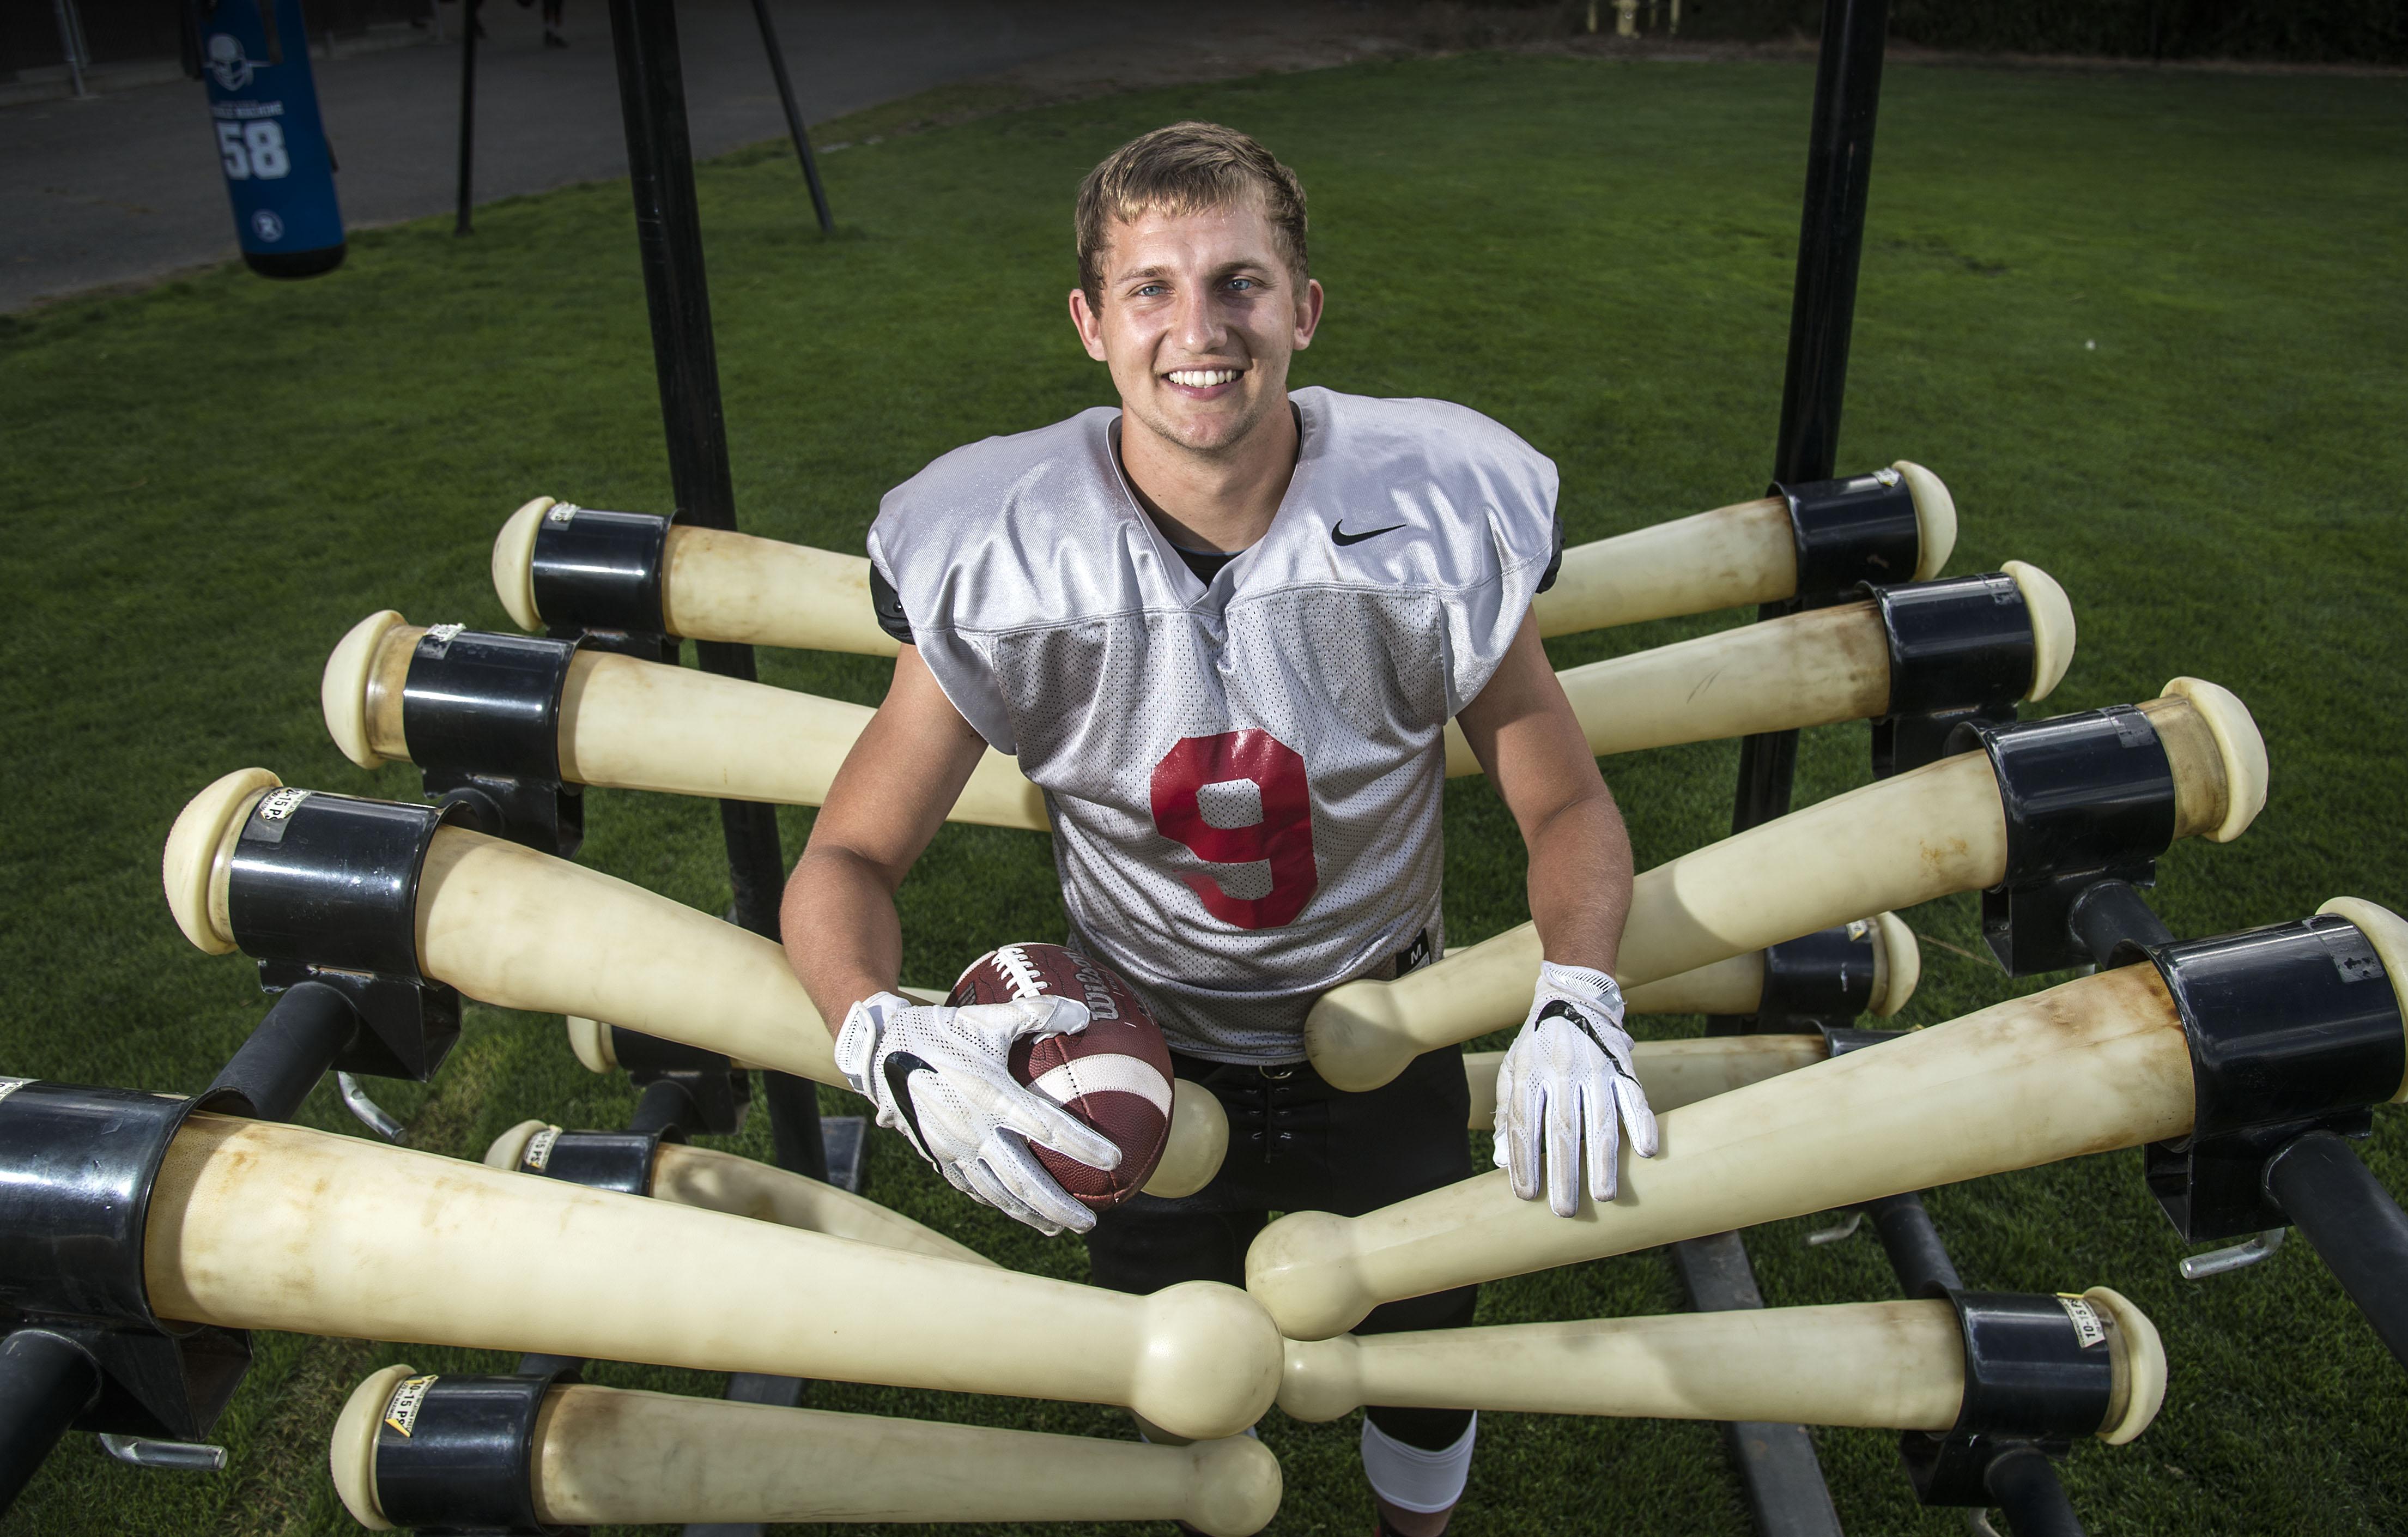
top-left (327, 1366), bottom-right (1281, 1537)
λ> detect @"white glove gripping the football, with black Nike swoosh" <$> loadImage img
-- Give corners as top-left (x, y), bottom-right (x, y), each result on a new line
top-left (835, 993), bottom-right (1120, 1238)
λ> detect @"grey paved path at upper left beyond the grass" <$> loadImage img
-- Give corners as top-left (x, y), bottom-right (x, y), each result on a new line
top-left (0, 0), bottom-right (1382, 311)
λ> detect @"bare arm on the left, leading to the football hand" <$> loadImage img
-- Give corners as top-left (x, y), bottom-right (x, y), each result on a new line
top-left (780, 646), bottom-right (987, 1033)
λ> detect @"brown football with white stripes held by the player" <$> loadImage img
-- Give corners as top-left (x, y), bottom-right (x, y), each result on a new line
top-left (944, 945), bottom-right (1170, 1212)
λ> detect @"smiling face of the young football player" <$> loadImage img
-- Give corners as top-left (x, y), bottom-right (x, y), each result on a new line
top-left (1069, 197), bottom-right (1322, 458)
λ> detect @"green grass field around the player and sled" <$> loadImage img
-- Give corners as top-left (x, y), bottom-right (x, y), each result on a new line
top-left (0, 56), bottom-right (2408, 1537)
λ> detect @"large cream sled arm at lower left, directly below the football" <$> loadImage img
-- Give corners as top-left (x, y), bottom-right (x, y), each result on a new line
top-left (142, 1113), bottom-right (1281, 1441)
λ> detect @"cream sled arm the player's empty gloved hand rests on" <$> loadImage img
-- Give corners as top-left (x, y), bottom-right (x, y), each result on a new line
top-left (1245, 904), bottom-right (2408, 1340)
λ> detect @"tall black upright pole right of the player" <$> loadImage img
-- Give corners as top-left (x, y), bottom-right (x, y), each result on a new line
top-left (1731, 0), bottom-right (1890, 833)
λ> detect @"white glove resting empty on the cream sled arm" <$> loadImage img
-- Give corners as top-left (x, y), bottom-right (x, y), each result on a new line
top-left (1495, 961), bottom-right (1657, 1217)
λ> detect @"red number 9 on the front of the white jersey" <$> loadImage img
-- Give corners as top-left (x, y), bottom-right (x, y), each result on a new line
top-left (1154, 730), bottom-right (1322, 928)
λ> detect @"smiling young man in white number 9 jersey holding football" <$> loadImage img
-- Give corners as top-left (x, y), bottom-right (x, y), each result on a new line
top-left (785, 123), bottom-right (1654, 1537)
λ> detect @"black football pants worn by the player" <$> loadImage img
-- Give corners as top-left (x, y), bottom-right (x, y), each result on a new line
top-left (1086, 1045), bottom-right (1478, 1453)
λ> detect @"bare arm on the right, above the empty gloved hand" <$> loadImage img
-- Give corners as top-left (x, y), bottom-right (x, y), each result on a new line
top-left (1454, 619), bottom-right (1630, 973)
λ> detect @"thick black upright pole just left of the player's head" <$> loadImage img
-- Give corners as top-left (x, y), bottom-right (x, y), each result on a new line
top-left (602, 0), bottom-right (818, 1180)
